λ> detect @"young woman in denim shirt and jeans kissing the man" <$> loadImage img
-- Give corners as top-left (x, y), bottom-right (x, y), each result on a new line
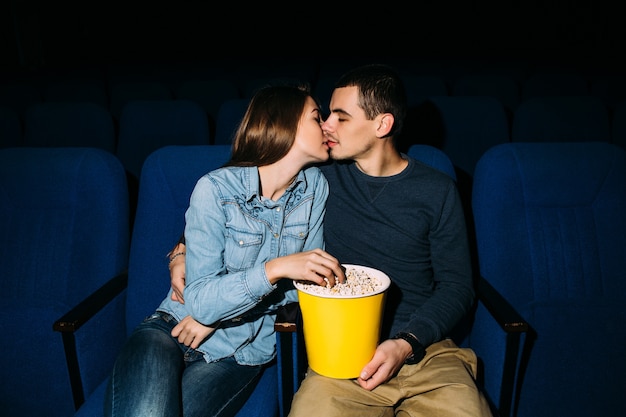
top-left (105, 86), bottom-right (345, 417)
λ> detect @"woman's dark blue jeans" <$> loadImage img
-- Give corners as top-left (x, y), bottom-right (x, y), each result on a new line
top-left (104, 312), bottom-right (262, 417)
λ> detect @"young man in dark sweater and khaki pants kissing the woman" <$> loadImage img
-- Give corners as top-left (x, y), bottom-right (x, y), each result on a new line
top-left (172, 65), bottom-right (491, 417)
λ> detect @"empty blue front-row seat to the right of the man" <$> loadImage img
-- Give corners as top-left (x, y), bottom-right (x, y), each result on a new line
top-left (472, 142), bottom-right (626, 417)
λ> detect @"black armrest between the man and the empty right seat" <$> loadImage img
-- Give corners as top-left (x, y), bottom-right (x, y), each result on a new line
top-left (477, 276), bottom-right (530, 416)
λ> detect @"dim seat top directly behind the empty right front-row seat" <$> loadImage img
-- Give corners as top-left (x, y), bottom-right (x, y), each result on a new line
top-left (511, 96), bottom-right (611, 142)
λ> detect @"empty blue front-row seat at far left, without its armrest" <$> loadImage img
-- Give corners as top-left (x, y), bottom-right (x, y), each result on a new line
top-left (0, 147), bottom-right (129, 417)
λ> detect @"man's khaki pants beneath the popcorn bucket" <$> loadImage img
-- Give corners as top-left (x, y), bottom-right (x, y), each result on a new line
top-left (289, 340), bottom-right (491, 417)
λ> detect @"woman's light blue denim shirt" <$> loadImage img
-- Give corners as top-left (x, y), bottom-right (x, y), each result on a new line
top-left (158, 163), bottom-right (328, 365)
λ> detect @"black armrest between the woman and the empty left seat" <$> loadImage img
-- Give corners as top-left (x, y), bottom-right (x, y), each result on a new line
top-left (52, 272), bottom-right (128, 410)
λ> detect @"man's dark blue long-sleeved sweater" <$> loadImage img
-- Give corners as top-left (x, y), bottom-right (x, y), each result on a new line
top-left (320, 156), bottom-right (474, 346)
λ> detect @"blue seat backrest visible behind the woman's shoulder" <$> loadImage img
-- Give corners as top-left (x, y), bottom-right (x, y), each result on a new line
top-left (126, 145), bottom-right (231, 331)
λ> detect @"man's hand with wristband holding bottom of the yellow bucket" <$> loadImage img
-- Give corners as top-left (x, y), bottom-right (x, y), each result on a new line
top-left (357, 339), bottom-right (411, 391)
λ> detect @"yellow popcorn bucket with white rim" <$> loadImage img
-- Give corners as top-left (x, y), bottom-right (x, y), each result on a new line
top-left (294, 265), bottom-right (391, 379)
